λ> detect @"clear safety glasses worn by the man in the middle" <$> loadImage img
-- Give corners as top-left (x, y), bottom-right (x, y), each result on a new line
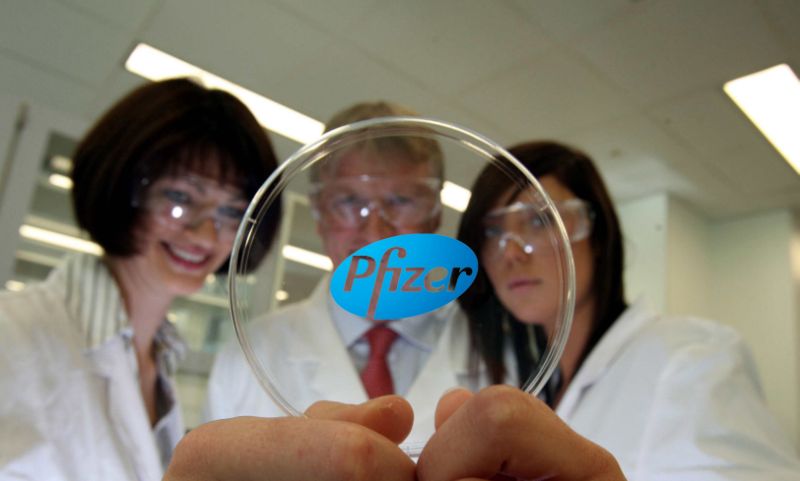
top-left (312, 175), bottom-right (442, 229)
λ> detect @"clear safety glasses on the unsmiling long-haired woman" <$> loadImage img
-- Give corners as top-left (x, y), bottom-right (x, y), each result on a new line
top-left (483, 199), bottom-right (594, 257)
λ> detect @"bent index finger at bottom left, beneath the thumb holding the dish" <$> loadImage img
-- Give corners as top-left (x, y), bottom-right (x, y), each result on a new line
top-left (164, 417), bottom-right (415, 481)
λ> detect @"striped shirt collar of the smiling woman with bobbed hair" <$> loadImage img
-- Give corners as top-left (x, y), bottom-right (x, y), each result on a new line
top-left (55, 254), bottom-right (186, 371)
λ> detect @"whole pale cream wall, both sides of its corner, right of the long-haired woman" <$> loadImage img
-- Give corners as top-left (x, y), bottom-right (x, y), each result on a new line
top-left (618, 194), bottom-right (800, 443)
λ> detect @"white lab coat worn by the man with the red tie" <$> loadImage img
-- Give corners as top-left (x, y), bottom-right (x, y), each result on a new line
top-left (205, 280), bottom-right (476, 447)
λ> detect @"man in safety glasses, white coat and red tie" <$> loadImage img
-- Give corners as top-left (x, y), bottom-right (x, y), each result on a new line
top-left (206, 102), bottom-right (466, 427)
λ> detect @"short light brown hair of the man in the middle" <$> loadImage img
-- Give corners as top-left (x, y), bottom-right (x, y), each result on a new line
top-left (309, 100), bottom-right (444, 183)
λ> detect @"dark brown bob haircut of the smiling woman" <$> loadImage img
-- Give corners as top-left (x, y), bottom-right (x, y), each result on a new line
top-left (72, 79), bottom-right (280, 257)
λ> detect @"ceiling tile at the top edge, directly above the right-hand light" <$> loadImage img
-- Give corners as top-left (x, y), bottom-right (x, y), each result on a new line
top-left (574, 0), bottom-right (784, 105)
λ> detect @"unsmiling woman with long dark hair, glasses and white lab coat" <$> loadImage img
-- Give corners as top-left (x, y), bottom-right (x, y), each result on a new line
top-left (458, 142), bottom-right (800, 480)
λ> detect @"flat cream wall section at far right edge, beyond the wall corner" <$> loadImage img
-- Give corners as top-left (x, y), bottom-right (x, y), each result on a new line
top-left (710, 210), bottom-right (800, 441)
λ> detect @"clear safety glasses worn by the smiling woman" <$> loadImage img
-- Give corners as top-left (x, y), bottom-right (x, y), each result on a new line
top-left (134, 176), bottom-right (246, 240)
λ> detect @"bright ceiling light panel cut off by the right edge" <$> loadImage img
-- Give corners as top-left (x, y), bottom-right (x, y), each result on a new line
top-left (724, 64), bottom-right (800, 174)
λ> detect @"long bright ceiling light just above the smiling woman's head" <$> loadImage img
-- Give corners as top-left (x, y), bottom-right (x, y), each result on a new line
top-left (125, 43), bottom-right (324, 144)
